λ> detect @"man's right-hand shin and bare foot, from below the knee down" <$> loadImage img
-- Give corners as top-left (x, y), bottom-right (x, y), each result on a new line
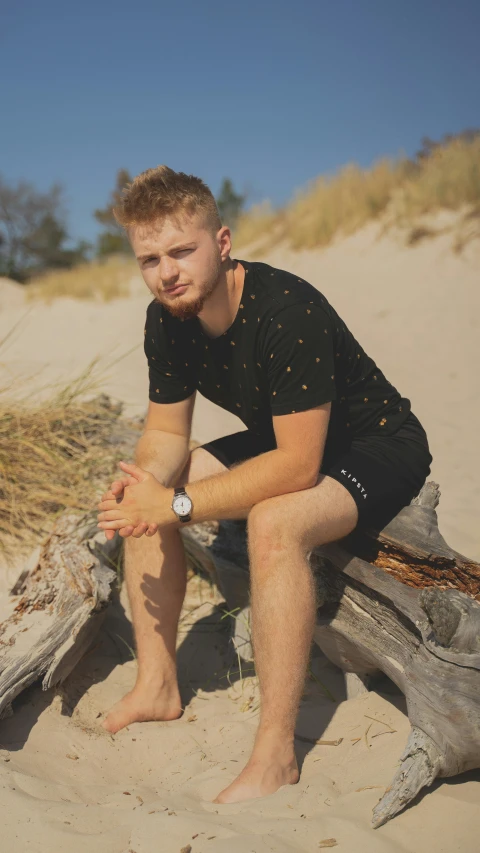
top-left (211, 543), bottom-right (315, 803)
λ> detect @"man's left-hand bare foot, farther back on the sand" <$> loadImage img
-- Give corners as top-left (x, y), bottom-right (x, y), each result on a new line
top-left (102, 684), bottom-right (182, 734)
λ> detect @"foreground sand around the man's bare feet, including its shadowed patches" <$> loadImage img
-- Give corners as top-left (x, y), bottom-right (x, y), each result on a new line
top-left (0, 577), bottom-right (480, 853)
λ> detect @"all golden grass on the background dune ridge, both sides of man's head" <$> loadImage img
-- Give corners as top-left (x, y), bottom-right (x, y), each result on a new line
top-left (17, 137), bottom-right (480, 303)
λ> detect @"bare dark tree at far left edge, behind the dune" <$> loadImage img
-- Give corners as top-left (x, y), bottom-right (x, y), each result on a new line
top-left (0, 176), bottom-right (90, 282)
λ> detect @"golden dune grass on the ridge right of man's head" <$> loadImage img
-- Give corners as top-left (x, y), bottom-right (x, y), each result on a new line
top-left (235, 137), bottom-right (480, 251)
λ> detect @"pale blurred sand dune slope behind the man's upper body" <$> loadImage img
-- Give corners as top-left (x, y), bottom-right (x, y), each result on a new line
top-left (0, 225), bottom-right (480, 559)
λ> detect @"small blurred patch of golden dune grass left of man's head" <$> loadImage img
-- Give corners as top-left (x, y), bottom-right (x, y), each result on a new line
top-left (27, 256), bottom-right (138, 303)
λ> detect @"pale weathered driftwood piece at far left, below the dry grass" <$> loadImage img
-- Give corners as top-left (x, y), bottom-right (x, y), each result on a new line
top-left (0, 514), bottom-right (120, 717)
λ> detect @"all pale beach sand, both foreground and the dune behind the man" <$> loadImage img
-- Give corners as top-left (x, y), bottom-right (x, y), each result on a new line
top-left (0, 226), bottom-right (480, 853)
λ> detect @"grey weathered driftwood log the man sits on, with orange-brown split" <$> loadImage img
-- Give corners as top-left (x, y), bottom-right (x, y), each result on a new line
top-left (182, 482), bottom-right (480, 827)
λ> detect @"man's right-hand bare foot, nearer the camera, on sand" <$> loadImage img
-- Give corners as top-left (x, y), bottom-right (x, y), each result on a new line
top-left (213, 746), bottom-right (300, 803)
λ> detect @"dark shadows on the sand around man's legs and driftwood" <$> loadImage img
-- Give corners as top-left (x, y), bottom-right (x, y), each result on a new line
top-left (0, 568), bottom-right (406, 784)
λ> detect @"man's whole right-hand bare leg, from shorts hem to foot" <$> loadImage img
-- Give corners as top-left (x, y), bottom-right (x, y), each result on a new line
top-left (215, 478), bottom-right (357, 803)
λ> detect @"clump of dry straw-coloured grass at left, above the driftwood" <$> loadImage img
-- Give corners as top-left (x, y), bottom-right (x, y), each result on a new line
top-left (0, 362), bottom-right (131, 556)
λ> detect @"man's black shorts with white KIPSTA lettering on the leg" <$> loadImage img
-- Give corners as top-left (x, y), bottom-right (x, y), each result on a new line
top-left (202, 412), bottom-right (432, 530)
